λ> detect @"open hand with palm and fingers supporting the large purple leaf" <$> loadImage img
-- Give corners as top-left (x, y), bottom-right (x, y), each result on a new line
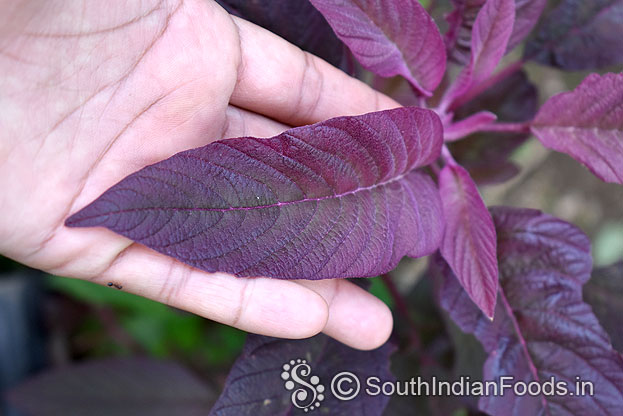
top-left (0, 0), bottom-right (397, 349)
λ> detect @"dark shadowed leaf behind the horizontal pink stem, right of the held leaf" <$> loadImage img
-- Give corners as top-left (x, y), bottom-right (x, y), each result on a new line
top-left (449, 71), bottom-right (538, 185)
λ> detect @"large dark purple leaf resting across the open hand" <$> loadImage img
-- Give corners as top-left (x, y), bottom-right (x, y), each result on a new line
top-left (66, 107), bottom-right (443, 279)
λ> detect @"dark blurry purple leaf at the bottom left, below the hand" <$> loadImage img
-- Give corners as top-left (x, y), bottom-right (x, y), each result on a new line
top-left (8, 358), bottom-right (215, 416)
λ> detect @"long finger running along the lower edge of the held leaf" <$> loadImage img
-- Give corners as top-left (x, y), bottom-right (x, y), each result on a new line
top-left (93, 244), bottom-right (328, 338)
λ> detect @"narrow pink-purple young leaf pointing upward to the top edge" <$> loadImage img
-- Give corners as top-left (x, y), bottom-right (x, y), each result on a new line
top-left (444, 0), bottom-right (515, 102)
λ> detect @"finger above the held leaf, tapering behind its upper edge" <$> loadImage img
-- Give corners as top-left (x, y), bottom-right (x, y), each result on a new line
top-left (230, 17), bottom-right (399, 126)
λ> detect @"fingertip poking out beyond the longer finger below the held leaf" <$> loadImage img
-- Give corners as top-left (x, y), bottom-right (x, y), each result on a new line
top-left (298, 279), bottom-right (393, 350)
